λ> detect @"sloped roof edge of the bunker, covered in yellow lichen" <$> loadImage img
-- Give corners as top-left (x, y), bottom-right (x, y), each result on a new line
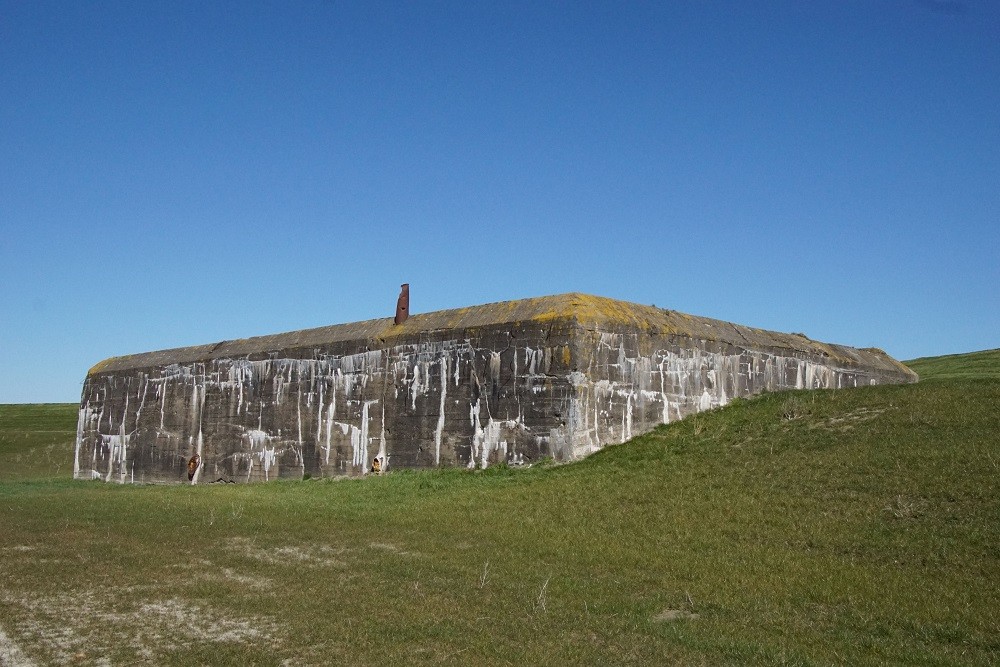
top-left (88, 292), bottom-right (912, 375)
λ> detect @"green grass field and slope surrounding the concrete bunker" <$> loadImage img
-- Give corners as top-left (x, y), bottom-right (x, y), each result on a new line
top-left (0, 351), bottom-right (1000, 666)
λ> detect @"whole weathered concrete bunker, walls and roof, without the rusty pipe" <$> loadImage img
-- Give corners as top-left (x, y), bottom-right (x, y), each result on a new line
top-left (74, 294), bottom-right (917, 483)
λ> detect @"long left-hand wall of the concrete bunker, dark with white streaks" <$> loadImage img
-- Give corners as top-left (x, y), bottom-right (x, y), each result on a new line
top-left (76, 340), bottom-right (565, 483)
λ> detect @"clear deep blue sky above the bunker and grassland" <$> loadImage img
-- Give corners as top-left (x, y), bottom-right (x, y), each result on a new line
top-left (0, 0), bottom-right (1000, 403)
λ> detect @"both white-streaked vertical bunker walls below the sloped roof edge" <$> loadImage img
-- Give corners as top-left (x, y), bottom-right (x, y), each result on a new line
top-left (76, 332), bottom-right (892, 482)
